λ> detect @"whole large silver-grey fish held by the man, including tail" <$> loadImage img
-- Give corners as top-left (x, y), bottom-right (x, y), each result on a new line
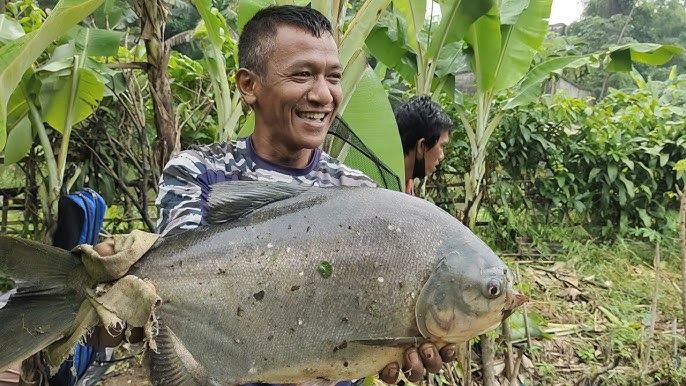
top-left (0, 181), bottom-right (526, 385)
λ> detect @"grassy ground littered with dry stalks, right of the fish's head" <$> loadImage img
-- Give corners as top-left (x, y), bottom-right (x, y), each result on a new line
top-left (486, 232), bottom-right (686, 385)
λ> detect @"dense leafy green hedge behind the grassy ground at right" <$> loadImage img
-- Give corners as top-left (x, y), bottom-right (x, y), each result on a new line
top-left (428, 68), bottom-right (686, 243)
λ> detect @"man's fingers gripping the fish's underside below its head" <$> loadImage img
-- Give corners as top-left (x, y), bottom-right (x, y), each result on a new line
top-left (379, 342), bottom-right (456, 385)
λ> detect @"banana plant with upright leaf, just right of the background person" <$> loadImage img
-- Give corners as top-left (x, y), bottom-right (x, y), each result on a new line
top-left (460, 0), bottom-right (552, 228)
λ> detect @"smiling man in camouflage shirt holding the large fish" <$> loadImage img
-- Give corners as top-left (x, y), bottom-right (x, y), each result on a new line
top-left (156, 6), bottom-right (455, 384)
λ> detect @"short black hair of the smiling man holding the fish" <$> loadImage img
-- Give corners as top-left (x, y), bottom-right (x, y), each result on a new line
top-left (238, 5), bottom-right (333, 76)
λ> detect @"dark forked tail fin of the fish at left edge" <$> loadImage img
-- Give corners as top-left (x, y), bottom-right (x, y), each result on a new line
top-left (0, 236), bottom-right (87, 371)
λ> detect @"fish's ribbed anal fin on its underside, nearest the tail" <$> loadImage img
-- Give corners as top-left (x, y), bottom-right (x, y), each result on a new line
top-left (150, 320), bottom-right (211, 386)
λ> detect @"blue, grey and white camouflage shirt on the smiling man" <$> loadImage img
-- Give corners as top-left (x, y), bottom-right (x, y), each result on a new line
top-left (155, 137), bottom-right (376, 235)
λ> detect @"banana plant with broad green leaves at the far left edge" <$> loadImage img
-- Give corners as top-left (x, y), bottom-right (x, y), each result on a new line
top-left (0, 0), bottom-right (110, 234)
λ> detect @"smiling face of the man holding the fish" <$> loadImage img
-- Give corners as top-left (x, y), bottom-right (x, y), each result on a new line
top-left (252, 26), bottom-right (343, 152)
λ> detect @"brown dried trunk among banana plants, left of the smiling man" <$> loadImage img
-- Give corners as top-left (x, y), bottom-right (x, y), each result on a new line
top-left (133, 0), bottom-right (181, 170)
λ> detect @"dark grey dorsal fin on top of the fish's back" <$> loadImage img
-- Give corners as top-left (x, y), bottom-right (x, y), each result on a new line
top-left (205, 181), bottom-right (312, 224)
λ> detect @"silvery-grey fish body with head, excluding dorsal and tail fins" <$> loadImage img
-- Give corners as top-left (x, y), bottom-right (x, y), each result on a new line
top-left (132, 182), bottom-right (514, 384)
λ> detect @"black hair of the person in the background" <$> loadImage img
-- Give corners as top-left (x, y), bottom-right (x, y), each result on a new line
top-left (395, 95), bottom-right (453, 155)
